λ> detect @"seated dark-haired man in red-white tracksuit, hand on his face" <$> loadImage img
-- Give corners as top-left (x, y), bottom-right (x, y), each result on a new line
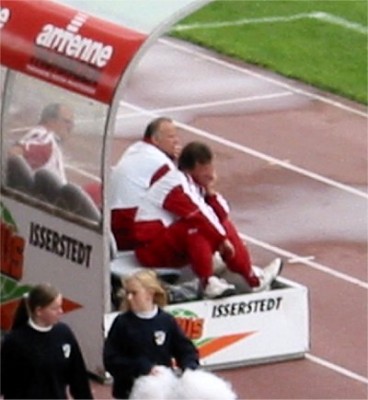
top-left (134, 142), bottom-right (282, 298)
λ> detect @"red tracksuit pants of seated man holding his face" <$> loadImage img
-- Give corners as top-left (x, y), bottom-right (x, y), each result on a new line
top-left (135, 219), bottom-right (259, 287)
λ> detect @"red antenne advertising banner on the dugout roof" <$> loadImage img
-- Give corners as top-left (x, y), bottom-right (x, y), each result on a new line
top-left (0, 0), bottom-right (147, 104)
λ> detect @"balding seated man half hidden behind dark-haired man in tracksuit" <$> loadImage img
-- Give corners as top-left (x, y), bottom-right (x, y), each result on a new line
top-left (110, 117), bottom-right (181, 250)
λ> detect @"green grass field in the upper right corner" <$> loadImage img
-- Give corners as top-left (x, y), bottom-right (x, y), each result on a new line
top-left (172, 0), bottom-right (368, 104)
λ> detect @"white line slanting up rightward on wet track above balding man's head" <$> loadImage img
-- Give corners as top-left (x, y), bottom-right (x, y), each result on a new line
top-left (117, 91), bottom-right (294, 119)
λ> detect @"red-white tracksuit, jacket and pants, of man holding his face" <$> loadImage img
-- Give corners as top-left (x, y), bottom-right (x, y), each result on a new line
top-left (134, 169), bottom-right (259, 287)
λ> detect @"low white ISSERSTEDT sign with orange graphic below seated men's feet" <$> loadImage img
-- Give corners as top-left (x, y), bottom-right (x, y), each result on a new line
top-left (167, 278), bottom-right (309, 368)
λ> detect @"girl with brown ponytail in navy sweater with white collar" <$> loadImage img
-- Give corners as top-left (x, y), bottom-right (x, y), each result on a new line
top-left (1, 284), bottom-right (93, 399)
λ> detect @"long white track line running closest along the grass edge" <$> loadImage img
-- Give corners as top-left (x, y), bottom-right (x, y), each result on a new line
top-left (159, 39), bottom-right (368, 118)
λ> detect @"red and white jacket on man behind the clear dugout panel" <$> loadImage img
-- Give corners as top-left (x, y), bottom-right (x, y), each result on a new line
top-left (18, 126), bottom-right (67, 183)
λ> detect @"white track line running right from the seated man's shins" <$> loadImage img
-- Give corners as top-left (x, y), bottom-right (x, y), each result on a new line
top-left (239, 233), bottom-right (368, 290)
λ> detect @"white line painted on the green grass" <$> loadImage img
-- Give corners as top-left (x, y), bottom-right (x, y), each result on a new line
top-left (172, 11), bottom-right (368, 35)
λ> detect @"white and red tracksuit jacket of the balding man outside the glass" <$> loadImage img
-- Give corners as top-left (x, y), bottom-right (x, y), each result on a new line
top-left (110, 141), bottom-right (176, 250)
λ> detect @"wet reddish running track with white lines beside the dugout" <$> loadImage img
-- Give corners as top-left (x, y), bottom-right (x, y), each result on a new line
top-left (93, 40), bottom-right (368, 399)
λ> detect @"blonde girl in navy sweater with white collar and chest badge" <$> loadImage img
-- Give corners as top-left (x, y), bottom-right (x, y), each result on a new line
top-left (103, 269), bottom-right (199, 399)
